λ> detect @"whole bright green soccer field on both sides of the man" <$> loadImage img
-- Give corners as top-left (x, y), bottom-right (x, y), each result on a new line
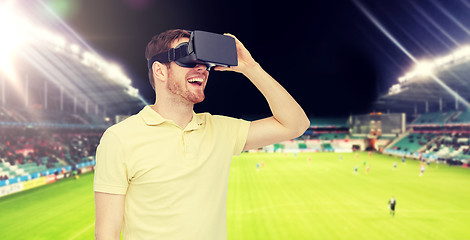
top-left (0, 153), bottom-right (470, 240)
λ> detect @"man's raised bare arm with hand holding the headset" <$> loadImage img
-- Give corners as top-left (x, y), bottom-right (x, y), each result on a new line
top-left (215, 34), bottom-right (310, 150)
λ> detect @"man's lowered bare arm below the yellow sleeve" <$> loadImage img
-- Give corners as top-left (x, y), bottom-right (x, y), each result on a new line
top-left (95, 192), bottom-right (125, 240)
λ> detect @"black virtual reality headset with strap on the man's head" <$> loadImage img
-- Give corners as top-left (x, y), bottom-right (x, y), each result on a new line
top-left (148, 31), bottom-right (238, 71)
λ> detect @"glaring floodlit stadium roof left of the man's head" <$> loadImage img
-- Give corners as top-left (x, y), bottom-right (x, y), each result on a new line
top-left (0, 1), bottom-right (147, 114)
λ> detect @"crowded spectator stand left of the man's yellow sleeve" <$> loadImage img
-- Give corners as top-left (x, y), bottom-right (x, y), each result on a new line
top-left (0, 124), bottom-right (103, 179)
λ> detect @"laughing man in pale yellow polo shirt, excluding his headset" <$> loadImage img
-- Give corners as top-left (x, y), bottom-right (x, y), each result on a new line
top-left (94, 30), bottom-right (310, 240)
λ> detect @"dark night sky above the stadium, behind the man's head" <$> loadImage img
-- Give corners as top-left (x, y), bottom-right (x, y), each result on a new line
top-left (50, 0), bottom-right (470, 117)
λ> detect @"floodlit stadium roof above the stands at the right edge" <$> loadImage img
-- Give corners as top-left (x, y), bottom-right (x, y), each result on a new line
top-left (375, 47), bottom-right (470, 113)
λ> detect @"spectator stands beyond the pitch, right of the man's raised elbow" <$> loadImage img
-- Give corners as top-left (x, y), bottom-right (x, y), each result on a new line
top-left (264, 110), bottom-right (470, 165)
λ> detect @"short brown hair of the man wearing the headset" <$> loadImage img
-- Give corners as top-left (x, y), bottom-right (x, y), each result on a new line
top-left (145, 29), bottom-right (190, 89)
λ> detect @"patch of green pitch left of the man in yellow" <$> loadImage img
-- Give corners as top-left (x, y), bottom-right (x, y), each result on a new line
top-left (0, 174), bottom-right (95, 240)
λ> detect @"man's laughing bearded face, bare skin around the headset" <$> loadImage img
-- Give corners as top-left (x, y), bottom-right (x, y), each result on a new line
top-left (167, 38), bottom-right (209, 104)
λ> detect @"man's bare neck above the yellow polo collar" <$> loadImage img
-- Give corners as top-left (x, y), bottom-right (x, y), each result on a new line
top-left (151, 101), bottom-right (194, 129)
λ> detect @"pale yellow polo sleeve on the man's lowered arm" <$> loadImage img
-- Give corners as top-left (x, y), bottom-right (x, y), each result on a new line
top-left (93, 130), bottom-right (128, 194)
